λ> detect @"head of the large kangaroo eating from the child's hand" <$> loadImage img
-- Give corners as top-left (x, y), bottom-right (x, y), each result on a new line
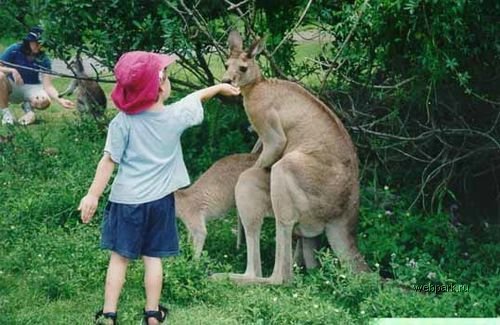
top-left (222, 31), bottom-right (264, 87)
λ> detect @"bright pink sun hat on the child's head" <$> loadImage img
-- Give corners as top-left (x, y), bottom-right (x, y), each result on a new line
top-left (111, 51), bottom-right (176, 114)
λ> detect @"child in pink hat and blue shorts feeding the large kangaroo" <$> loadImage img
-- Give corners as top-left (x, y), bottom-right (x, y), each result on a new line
top-left (78, 51), bottom-right (240, 324)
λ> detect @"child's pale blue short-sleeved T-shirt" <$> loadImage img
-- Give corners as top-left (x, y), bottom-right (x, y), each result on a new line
top-left (104, 94), bottom-right (203, 204)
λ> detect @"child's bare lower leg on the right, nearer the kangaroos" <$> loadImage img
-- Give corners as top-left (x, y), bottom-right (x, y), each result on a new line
top-left (142, 256), bottom-right (163, 325)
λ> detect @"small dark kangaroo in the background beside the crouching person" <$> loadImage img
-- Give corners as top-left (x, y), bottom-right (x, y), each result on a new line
top-left (59, 55), bottom-right (107, 120)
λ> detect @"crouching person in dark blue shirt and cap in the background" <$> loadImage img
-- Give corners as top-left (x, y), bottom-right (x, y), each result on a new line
top-left (0, 27), bottom-right (74, 125)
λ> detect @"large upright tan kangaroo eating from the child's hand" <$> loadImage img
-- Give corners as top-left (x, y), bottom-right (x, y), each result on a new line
top-left (215, 32), bottom-right (368, 284)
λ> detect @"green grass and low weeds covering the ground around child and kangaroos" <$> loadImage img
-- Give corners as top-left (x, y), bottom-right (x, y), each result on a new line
top-left (0, 39), bottom-right (500, 324)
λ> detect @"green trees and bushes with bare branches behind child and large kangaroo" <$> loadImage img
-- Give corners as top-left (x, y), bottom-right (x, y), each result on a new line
top-left (2, 0), bottom-right (500, 219)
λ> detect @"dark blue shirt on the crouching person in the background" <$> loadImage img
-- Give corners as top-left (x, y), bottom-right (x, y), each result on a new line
top-left (0, 43), bottom-right (52, 85)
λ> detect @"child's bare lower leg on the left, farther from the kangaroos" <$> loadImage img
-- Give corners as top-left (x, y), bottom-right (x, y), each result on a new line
top-left (103, 252), bottom-right (128, 313)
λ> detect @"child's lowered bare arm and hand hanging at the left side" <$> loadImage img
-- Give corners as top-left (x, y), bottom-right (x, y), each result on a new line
top-left (78, 153), bottom-right (115, 223)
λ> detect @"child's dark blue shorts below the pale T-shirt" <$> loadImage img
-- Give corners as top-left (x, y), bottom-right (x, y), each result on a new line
top-left (101, 193), bottom-right (179, 259)
